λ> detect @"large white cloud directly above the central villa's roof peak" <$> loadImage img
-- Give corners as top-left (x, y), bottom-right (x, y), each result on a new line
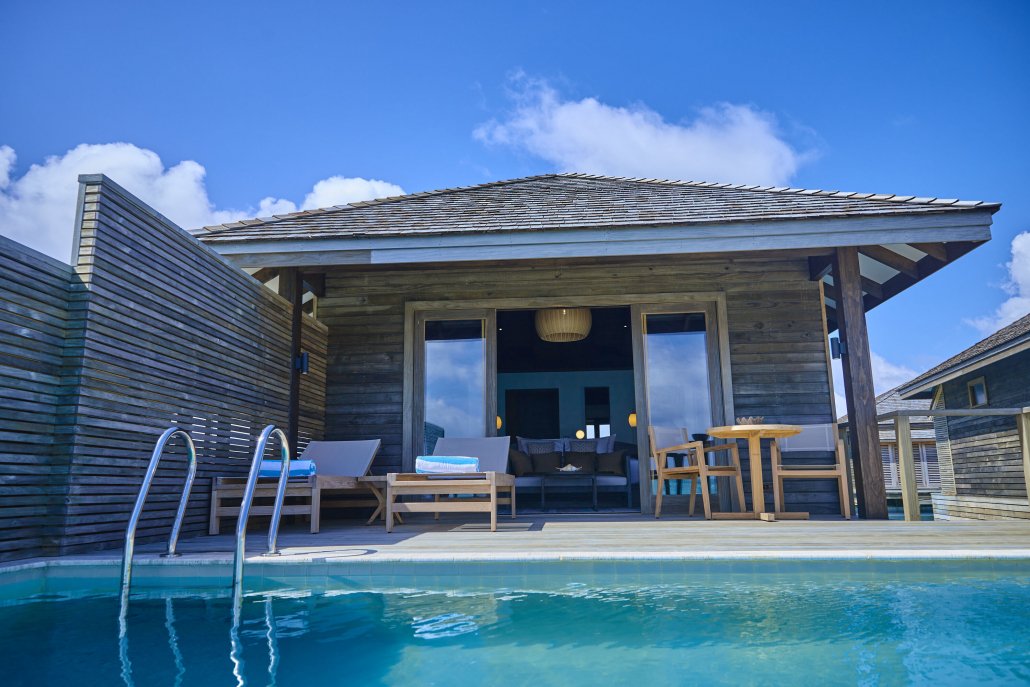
top-left (473, 75), bottom-right (808, 185)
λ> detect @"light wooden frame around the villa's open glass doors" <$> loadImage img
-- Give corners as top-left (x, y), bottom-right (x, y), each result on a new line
top-left (401, 291), bottom-right (733, 504)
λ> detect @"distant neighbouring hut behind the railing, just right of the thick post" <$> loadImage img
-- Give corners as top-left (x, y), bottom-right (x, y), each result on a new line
top-left (837, 387), bottom-right (940, 504)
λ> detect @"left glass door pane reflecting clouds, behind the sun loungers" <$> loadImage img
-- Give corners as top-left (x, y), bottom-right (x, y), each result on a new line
top-left (416, 318), bottom-right (487, 454)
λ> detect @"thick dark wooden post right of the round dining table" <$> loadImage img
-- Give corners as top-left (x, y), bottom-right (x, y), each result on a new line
top-left (833, 246), bottom-right (887, 519)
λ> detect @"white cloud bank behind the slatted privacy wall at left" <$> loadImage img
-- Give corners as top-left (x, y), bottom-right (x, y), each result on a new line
top-left (0, 143), bottom-right (404, 260)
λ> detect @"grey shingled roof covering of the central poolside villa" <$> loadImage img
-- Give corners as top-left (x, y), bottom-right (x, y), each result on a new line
top-left (197, 173), bottom-right (1000, 243)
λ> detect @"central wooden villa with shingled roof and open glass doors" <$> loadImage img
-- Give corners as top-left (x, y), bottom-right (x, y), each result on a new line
top-left (197, 174), bottom-right (999, 517)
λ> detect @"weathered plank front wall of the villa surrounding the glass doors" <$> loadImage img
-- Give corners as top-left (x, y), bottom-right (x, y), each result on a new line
top-left (318, 255), bottom-right (839, 513)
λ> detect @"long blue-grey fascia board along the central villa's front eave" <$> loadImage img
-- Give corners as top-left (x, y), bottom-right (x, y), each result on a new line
top-left (199, 207), bottom-right (993, 267)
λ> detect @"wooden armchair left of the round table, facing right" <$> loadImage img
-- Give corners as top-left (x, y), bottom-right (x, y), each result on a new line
top-left (647, 425), bottom-right (744, 520)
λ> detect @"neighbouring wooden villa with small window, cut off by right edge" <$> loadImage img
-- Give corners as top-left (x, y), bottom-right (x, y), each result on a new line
top-left (899, 314), bottom-right (1030, 519)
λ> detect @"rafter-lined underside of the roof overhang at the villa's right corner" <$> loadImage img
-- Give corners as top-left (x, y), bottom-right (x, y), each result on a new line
top-left (809, 241), bottom-right (983, 332)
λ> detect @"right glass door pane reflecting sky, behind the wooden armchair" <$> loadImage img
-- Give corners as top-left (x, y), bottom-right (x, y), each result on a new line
top-left (644, 312), bottom-right (712, 434)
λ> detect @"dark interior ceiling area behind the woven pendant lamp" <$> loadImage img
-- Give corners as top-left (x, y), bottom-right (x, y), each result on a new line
top-left (497, 308), bottom-right (633, 373)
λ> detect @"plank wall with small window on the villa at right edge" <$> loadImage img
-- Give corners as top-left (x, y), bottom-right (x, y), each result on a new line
top-left (943, 351), bottom-right (1030, 500)
